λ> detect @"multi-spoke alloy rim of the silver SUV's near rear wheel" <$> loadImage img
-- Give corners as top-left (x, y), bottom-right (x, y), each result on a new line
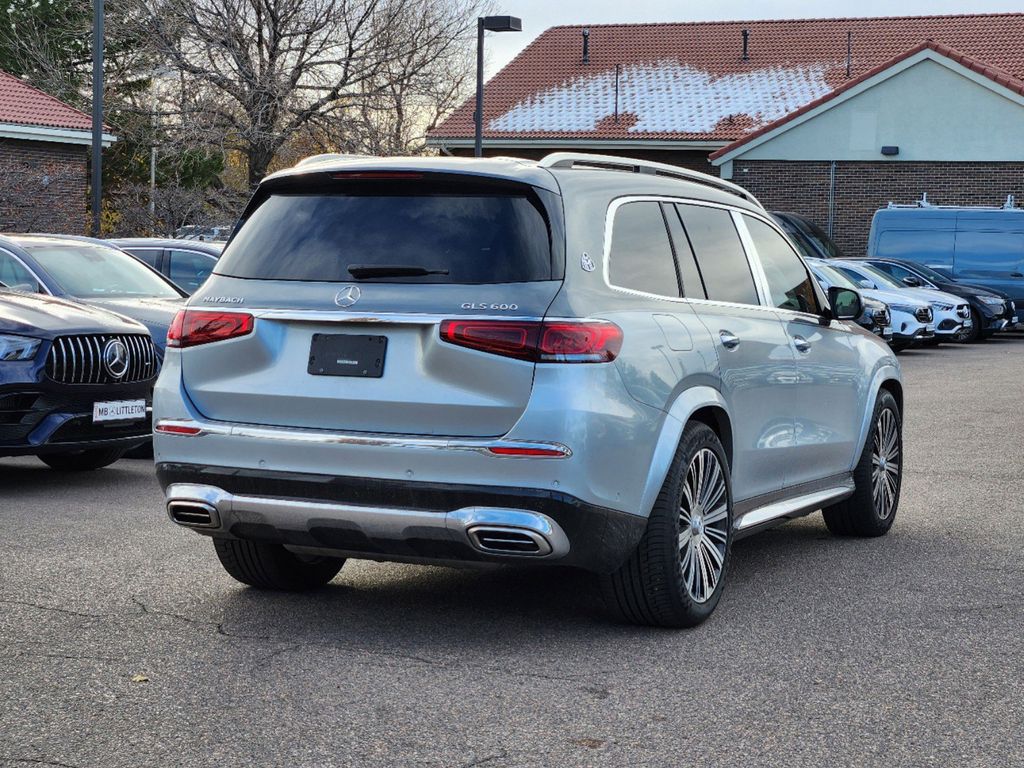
top-left (679, 449), bottom-right (729, 603)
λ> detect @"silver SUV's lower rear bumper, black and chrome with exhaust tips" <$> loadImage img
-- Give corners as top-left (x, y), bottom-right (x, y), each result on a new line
top-left (157, 463), bottom-right (646, 572)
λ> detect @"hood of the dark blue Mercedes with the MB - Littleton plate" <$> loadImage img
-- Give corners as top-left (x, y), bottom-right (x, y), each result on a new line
top-left (0, 289), bottom-right (145, 339)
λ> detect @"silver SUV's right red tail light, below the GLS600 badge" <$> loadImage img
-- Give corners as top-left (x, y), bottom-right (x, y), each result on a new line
top-left (441, 319), bottom-right (623, 362)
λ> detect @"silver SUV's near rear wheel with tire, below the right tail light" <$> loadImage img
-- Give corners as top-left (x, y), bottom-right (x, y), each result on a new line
top-left (601, 422), bottom-right (732, 628)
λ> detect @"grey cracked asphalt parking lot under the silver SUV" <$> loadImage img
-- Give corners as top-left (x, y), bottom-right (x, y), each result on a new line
top-left (0, 335), bottom-right (1024, 768)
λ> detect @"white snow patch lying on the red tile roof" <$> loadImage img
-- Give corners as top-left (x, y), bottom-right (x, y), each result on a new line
top-left (487, 60), bottom-right (840, 134)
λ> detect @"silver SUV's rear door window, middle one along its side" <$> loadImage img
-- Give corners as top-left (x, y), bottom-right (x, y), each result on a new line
top-left (677, 205), bottom-right (761, 304)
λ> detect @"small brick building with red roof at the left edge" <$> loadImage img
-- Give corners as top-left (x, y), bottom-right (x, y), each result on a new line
top-left (0, 72), bottom-right (115, 234)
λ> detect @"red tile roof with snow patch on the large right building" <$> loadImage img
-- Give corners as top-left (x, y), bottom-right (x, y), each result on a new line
top-left (431, 13), bottom-right (1024, 142)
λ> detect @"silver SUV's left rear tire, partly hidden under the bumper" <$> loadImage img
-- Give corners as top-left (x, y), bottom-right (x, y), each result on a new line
top-left (213, 539), bottom-right (345, 592)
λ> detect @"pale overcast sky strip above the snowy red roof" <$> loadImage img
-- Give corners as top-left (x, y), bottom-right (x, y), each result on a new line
top-left (486, 0), bottom-right (1024, 77)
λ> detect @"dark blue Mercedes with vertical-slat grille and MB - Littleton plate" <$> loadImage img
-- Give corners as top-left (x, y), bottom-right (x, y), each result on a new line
top-left (0, 289), bottom-right (159, 470)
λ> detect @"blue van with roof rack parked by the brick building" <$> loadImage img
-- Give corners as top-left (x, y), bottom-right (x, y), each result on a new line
top-left (867, 199), bottom-right (1024, 323)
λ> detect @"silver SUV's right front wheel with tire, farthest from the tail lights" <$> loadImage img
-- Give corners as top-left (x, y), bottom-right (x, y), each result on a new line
top-left (821, 389), bottom-right (903, 537)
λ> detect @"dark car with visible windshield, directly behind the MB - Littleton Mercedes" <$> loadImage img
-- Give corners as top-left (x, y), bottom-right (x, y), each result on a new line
top-left (0, 234), bottom-right (185, 356)
